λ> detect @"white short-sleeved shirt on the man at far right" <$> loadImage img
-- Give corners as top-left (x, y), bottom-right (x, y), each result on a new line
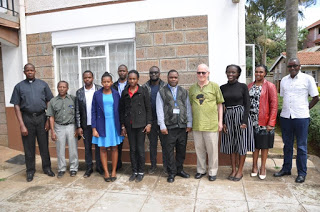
top-left (280, 72), bottom-right (319, 119)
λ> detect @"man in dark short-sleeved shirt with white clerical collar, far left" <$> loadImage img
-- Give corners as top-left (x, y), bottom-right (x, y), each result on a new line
top-left (10, 63), bottom-right (55, 182)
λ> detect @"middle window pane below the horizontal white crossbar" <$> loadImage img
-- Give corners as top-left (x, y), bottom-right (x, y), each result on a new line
top-left (81, 58), bottom-right (106, 85)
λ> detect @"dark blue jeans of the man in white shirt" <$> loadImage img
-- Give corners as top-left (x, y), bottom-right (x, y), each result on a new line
top-left (280, 117), bottom-right (310, 176)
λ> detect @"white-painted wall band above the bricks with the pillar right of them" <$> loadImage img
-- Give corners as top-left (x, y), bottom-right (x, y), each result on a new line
top-left (4, 0), bottom-right (245, 106)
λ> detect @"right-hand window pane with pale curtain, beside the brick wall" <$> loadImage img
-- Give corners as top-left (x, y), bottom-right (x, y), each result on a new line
top-left (109, 42), bottom-right (135, 82)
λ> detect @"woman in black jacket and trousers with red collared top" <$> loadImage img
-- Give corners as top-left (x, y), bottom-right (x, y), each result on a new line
top-left (120, 70), bottom-right (152, 182)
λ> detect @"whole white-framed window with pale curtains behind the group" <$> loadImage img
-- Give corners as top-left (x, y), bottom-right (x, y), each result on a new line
top-left (56, 40), bottom-right (135, 95)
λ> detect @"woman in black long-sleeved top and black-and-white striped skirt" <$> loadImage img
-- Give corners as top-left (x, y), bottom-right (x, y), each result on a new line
top-left (220, 65), bottom-right (254, 181)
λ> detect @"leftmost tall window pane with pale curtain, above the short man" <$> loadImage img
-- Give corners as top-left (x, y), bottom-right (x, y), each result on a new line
top-left (57, 47), bottom-right (79, 95)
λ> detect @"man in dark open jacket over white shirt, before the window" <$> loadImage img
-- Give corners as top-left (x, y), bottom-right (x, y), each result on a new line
top-left (75, 70), bottom-right (103, 178)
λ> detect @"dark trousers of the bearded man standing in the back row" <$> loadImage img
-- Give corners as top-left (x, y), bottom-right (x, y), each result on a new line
top-left (148, 121), bottom-right (167, 170)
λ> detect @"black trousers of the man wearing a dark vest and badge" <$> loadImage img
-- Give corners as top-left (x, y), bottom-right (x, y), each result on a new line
top-left (164, 128), bottom-right (188, 175)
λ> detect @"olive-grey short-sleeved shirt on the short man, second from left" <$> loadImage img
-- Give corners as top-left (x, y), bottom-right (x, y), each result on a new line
top-left (47, 94), bottom-right (75, 124)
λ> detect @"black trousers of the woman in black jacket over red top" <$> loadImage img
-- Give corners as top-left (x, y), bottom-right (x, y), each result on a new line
top-left (126, 126), bottom-right (146, 173)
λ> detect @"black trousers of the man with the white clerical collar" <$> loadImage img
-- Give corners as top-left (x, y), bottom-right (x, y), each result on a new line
top-left (22, 112), bottom-right (51, 174)
